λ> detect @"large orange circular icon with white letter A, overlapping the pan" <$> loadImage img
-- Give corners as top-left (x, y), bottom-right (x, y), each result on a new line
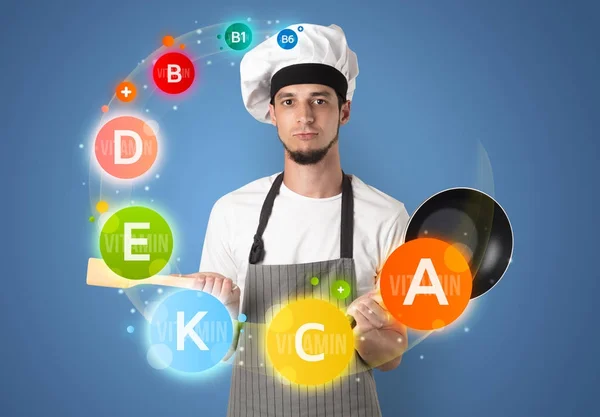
top-left (380, 238), bottom-right (473, 330)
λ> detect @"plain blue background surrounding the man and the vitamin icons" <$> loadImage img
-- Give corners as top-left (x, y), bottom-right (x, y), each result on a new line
top-left (0, 0), bottom-right (600, 417)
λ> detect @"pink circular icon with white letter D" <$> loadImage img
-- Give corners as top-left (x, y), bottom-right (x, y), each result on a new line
top-left (94, 116), bottom-right (158, 179)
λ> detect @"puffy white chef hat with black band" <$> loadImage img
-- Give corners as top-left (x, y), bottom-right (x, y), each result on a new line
top-left (240, 24), bottom-right (358, 123)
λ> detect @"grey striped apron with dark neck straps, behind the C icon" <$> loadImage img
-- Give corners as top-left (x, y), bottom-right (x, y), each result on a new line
top-left (227, 173), bottom-right (381, 417)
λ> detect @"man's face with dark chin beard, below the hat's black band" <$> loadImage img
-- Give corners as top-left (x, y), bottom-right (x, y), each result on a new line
top-left (269, 84), bottom-right (350, 165)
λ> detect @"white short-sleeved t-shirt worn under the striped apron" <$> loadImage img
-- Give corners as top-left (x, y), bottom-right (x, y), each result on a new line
top-left (200, 173), bottom-right (409, 300)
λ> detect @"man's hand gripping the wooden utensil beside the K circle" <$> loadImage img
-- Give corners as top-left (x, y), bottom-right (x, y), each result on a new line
top-left (171, 272), bottom-right (240, 320)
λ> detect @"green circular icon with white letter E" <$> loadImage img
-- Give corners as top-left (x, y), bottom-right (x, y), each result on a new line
top-left (100, 206), bottom-right (173, 279)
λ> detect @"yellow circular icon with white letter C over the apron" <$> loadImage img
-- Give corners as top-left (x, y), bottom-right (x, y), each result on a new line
top-left (266, 299), bottom-right (354, 386)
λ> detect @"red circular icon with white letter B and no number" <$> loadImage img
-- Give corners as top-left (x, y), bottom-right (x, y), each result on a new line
top-left (152, 52), bottom-right (196, 94)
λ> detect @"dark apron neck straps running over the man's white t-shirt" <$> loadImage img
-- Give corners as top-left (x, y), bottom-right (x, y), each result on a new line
top-left (248, 171), bottom-right (354, 265)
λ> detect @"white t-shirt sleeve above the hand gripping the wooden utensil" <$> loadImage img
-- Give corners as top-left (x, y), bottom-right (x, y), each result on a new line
top-left (200, 199), bottom-right (237, 282)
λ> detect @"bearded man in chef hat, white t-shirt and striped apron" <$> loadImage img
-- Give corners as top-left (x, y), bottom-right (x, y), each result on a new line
top-left (180, 24), bottom-right (409, 417)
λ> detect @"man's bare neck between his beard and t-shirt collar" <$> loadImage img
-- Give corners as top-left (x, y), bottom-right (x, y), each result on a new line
top-left (283, 149), bottom-right (342, 198)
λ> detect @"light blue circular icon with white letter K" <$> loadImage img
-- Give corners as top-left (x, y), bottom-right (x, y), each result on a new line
top-left (148, 290), bottom-right (233, 372)
